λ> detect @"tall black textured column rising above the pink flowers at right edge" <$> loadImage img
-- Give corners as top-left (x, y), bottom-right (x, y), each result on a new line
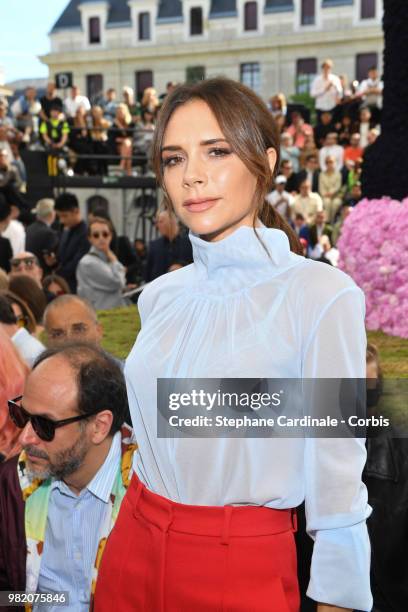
top-left (362, 0), bottom-right (408, 200)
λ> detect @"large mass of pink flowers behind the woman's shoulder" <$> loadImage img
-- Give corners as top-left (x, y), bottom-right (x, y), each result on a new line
top-left (337, 198), bottom-right (408, 338)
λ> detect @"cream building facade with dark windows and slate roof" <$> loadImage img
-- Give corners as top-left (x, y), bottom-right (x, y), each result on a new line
top-left (41, 0), bottom-right (383, 100)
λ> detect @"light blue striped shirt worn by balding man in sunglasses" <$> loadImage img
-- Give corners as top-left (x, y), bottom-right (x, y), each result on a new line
top-left (34, 432), bottom-right (121, 612)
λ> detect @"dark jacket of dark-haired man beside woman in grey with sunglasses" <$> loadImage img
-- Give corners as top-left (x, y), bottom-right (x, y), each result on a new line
top-left (56, 221), bottom-right (90, 293)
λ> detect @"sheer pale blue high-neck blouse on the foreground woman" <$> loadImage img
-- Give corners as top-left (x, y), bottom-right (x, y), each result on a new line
top-left (125, 226), bottom-right (372, 610)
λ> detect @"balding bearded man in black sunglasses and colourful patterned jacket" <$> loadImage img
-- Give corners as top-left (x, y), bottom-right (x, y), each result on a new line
top-left (0, 343), bottom-right (136, 612)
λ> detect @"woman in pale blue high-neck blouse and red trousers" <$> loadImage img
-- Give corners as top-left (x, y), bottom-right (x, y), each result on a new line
top-left (95, 78), bottom-right (371, 612)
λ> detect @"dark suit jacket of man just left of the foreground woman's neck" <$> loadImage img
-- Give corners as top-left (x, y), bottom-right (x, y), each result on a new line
top-left (145, 234), bottom-right (193, 282)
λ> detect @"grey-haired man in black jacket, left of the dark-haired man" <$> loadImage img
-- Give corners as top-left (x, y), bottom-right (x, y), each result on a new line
top-left (26, 198), bottom-right (58, 274)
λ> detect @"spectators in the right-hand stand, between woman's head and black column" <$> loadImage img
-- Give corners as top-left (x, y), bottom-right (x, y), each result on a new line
top-left (268, 59), bottom-right (383, 265)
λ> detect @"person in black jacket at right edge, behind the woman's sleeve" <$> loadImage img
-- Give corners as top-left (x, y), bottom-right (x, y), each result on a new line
top-left (363, 344), bottom-right (408, 612)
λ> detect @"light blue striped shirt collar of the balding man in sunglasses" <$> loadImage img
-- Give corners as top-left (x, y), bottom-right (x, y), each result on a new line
top-left (51, 431), bottom-right (121, 503)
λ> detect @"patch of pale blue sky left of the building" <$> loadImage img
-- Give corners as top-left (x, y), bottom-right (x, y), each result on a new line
top-left (0, 0), bottom-right (69, 83)
